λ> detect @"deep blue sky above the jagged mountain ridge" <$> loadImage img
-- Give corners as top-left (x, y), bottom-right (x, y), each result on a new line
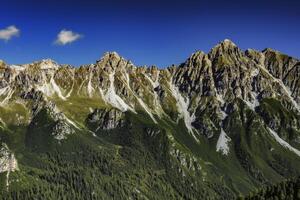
top-left (0, 0), bottom-right (300, 67)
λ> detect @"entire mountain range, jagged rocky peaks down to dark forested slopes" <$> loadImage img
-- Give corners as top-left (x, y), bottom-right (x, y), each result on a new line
top-left (0, 39), bottom-right (300, 200)
